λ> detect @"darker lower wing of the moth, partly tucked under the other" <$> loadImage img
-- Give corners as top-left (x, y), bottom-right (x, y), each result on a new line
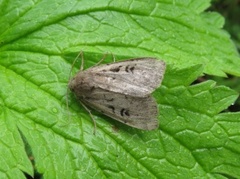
top-left (81, 89), bottom-right (158, 130)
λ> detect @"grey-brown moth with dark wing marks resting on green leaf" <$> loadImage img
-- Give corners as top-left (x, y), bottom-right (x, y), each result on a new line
top-left (68, 58), bottom-right (166, 130)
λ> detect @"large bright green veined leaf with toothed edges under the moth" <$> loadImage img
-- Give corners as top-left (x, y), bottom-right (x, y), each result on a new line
top-left (0, 0), bottom-right (240, 178)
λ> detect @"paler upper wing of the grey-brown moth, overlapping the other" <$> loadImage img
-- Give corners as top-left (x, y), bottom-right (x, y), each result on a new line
top-left (86, 58), bottom-right (166, 97)
